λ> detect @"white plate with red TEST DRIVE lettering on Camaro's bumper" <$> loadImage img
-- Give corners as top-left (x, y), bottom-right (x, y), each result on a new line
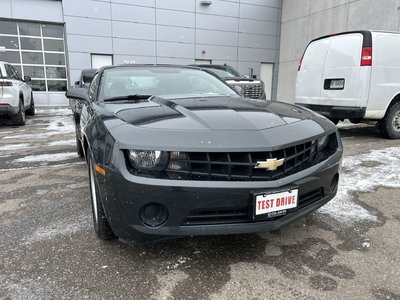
top-left (254, 189), bottom-right (298, 217)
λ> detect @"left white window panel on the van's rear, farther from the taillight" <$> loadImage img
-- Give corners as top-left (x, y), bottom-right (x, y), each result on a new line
top-left (301, 39), bottom-right (331, 70)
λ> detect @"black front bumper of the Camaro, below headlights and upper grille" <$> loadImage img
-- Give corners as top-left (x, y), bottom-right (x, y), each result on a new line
top-left (97, 149), bottom-right (342, 242)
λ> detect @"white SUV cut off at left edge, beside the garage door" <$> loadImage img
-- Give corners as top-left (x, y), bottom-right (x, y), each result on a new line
top-left (0, 61), bottom-right (35, 126)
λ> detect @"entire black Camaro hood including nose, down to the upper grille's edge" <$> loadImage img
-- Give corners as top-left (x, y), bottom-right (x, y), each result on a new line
top-left (95, 97), bottom-right (336, 152)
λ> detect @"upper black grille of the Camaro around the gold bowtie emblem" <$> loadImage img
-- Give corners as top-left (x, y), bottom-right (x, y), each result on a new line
top-left (165, 140), bottom-right (325, 181)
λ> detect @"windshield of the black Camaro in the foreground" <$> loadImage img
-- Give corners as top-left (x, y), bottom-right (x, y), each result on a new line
top-left (99, 66), bottom-right (239, 101)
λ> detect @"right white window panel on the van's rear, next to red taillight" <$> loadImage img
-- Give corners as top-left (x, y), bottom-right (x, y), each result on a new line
top-left (325, 34), bottom-right (363, 68)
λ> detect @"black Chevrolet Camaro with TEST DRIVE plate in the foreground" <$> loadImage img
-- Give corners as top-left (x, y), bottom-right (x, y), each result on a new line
top-left (66, 65), bottom-right (343, 242)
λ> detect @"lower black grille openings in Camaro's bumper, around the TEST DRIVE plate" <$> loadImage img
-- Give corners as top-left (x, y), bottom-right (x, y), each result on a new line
top-left (181, 188), bottom-right (324, 226)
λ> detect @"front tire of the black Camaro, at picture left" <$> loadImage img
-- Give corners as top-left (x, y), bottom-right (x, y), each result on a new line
top-left (88, 153), bottom-right (116, 240)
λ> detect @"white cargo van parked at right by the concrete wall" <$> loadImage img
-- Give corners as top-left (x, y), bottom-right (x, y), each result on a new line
top-left (295, 31), bottom-right (400, 139)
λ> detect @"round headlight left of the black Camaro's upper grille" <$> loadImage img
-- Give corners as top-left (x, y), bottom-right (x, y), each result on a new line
top-left (128, 150), bottom-right (168, 171)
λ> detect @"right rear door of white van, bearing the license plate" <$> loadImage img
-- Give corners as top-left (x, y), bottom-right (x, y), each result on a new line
top-left (320, 33), bottom-right (371, 107)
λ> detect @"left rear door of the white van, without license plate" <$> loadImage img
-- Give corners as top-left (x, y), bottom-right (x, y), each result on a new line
top-left (295, 38), bottom-right (331, 105)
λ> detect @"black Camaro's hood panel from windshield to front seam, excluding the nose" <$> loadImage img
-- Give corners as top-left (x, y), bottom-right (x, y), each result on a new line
top-left (100, 96), bottom-right (312, 131)
